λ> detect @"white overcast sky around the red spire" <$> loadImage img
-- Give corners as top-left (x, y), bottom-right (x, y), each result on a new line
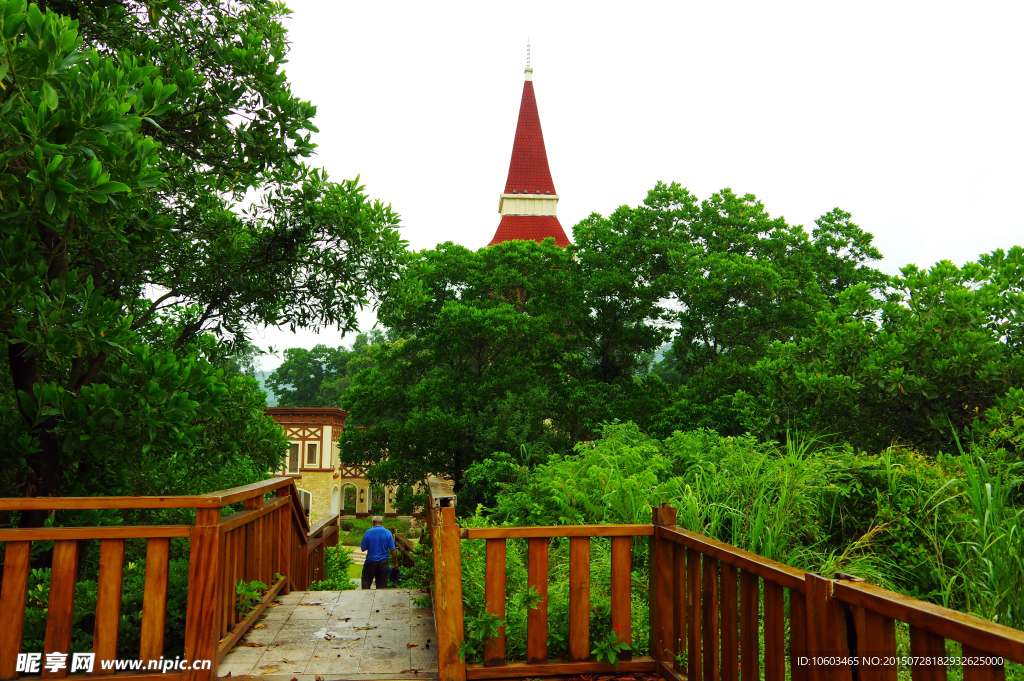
top-left (247, 0), bottom-right (1024, 369)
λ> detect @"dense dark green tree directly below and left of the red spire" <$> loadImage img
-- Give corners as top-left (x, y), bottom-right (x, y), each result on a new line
top-left (342, 241), bottom-right (572, 487)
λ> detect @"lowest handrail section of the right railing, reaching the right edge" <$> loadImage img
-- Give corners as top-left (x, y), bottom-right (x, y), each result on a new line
top-left (833, 582), bottom-right (1024, 665)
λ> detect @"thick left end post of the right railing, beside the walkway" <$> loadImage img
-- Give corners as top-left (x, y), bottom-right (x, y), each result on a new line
top-left (430, 506), bottom-right (466, 681)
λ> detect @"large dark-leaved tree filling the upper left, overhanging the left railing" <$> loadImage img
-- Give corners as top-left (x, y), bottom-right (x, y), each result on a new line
top-left (0, 0), bottom-right (401, 525)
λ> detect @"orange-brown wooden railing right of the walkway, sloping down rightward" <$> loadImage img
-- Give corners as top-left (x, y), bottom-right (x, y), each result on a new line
top-left (428, 496), bottom-right (1024, 681)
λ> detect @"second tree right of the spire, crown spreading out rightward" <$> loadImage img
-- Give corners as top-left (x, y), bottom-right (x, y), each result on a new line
top-left (638, 183), bottom-right (886, 434)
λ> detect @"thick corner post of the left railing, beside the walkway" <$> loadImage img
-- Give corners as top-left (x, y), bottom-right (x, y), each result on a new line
top-left (182, 508), bottom-right (227, 681)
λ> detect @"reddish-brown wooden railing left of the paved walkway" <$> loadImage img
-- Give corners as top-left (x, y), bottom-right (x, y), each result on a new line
top-left (0, 478), bottom-right (327, 681)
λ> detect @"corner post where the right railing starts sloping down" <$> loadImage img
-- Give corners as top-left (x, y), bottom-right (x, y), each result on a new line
top-left (648, 504), bottom-right (681, 673)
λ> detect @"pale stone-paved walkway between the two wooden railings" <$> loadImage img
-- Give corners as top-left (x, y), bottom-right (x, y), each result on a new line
top-left (217, 589), bottom-right (437, 681)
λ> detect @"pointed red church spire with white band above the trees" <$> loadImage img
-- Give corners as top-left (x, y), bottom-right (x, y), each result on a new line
top-left (487, 52), bottom-right (569, 247)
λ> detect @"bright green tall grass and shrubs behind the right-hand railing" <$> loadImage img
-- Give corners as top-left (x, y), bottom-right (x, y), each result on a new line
top-left (440, 424), bottom-right (1024, 659)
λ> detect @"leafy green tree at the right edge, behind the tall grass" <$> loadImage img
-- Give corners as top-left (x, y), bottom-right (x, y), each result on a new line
top-left (757, 247), bottom-right (1024, 452)
